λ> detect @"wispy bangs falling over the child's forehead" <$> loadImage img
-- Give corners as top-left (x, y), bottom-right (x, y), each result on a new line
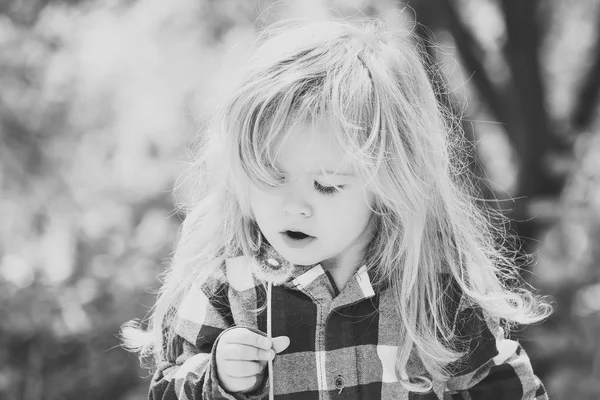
top-left (229, 32), bottom-right (383, 186)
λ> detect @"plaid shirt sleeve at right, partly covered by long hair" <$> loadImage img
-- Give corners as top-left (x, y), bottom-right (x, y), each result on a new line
top-left (446, 309), bottom-right (548, 400)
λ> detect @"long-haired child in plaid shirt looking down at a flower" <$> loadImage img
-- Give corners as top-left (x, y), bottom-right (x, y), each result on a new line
top-left (123, 17), bottom-right (549, 400)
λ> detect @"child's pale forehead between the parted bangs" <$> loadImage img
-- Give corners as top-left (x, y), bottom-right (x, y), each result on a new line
top-left (275, 118), bottom-right (354, 175)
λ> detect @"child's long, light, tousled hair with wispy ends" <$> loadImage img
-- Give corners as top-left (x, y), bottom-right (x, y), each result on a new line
top-left (123, 21), bottom-right (550, 392)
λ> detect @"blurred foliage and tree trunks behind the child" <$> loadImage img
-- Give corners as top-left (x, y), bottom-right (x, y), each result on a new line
top-left (0, 0), bottom-right (600, 400)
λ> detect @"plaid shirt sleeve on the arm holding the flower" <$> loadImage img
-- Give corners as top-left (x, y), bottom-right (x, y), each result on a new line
top-left (148, 272), bottom-right (264, 400)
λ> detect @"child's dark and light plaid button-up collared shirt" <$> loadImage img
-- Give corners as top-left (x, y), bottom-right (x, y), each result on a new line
top-left (149, 257), bottom-right (547, 400)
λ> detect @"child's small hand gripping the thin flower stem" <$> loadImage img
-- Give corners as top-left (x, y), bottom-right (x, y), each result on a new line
top-left (216, 328), bottom-right (290, 393)
